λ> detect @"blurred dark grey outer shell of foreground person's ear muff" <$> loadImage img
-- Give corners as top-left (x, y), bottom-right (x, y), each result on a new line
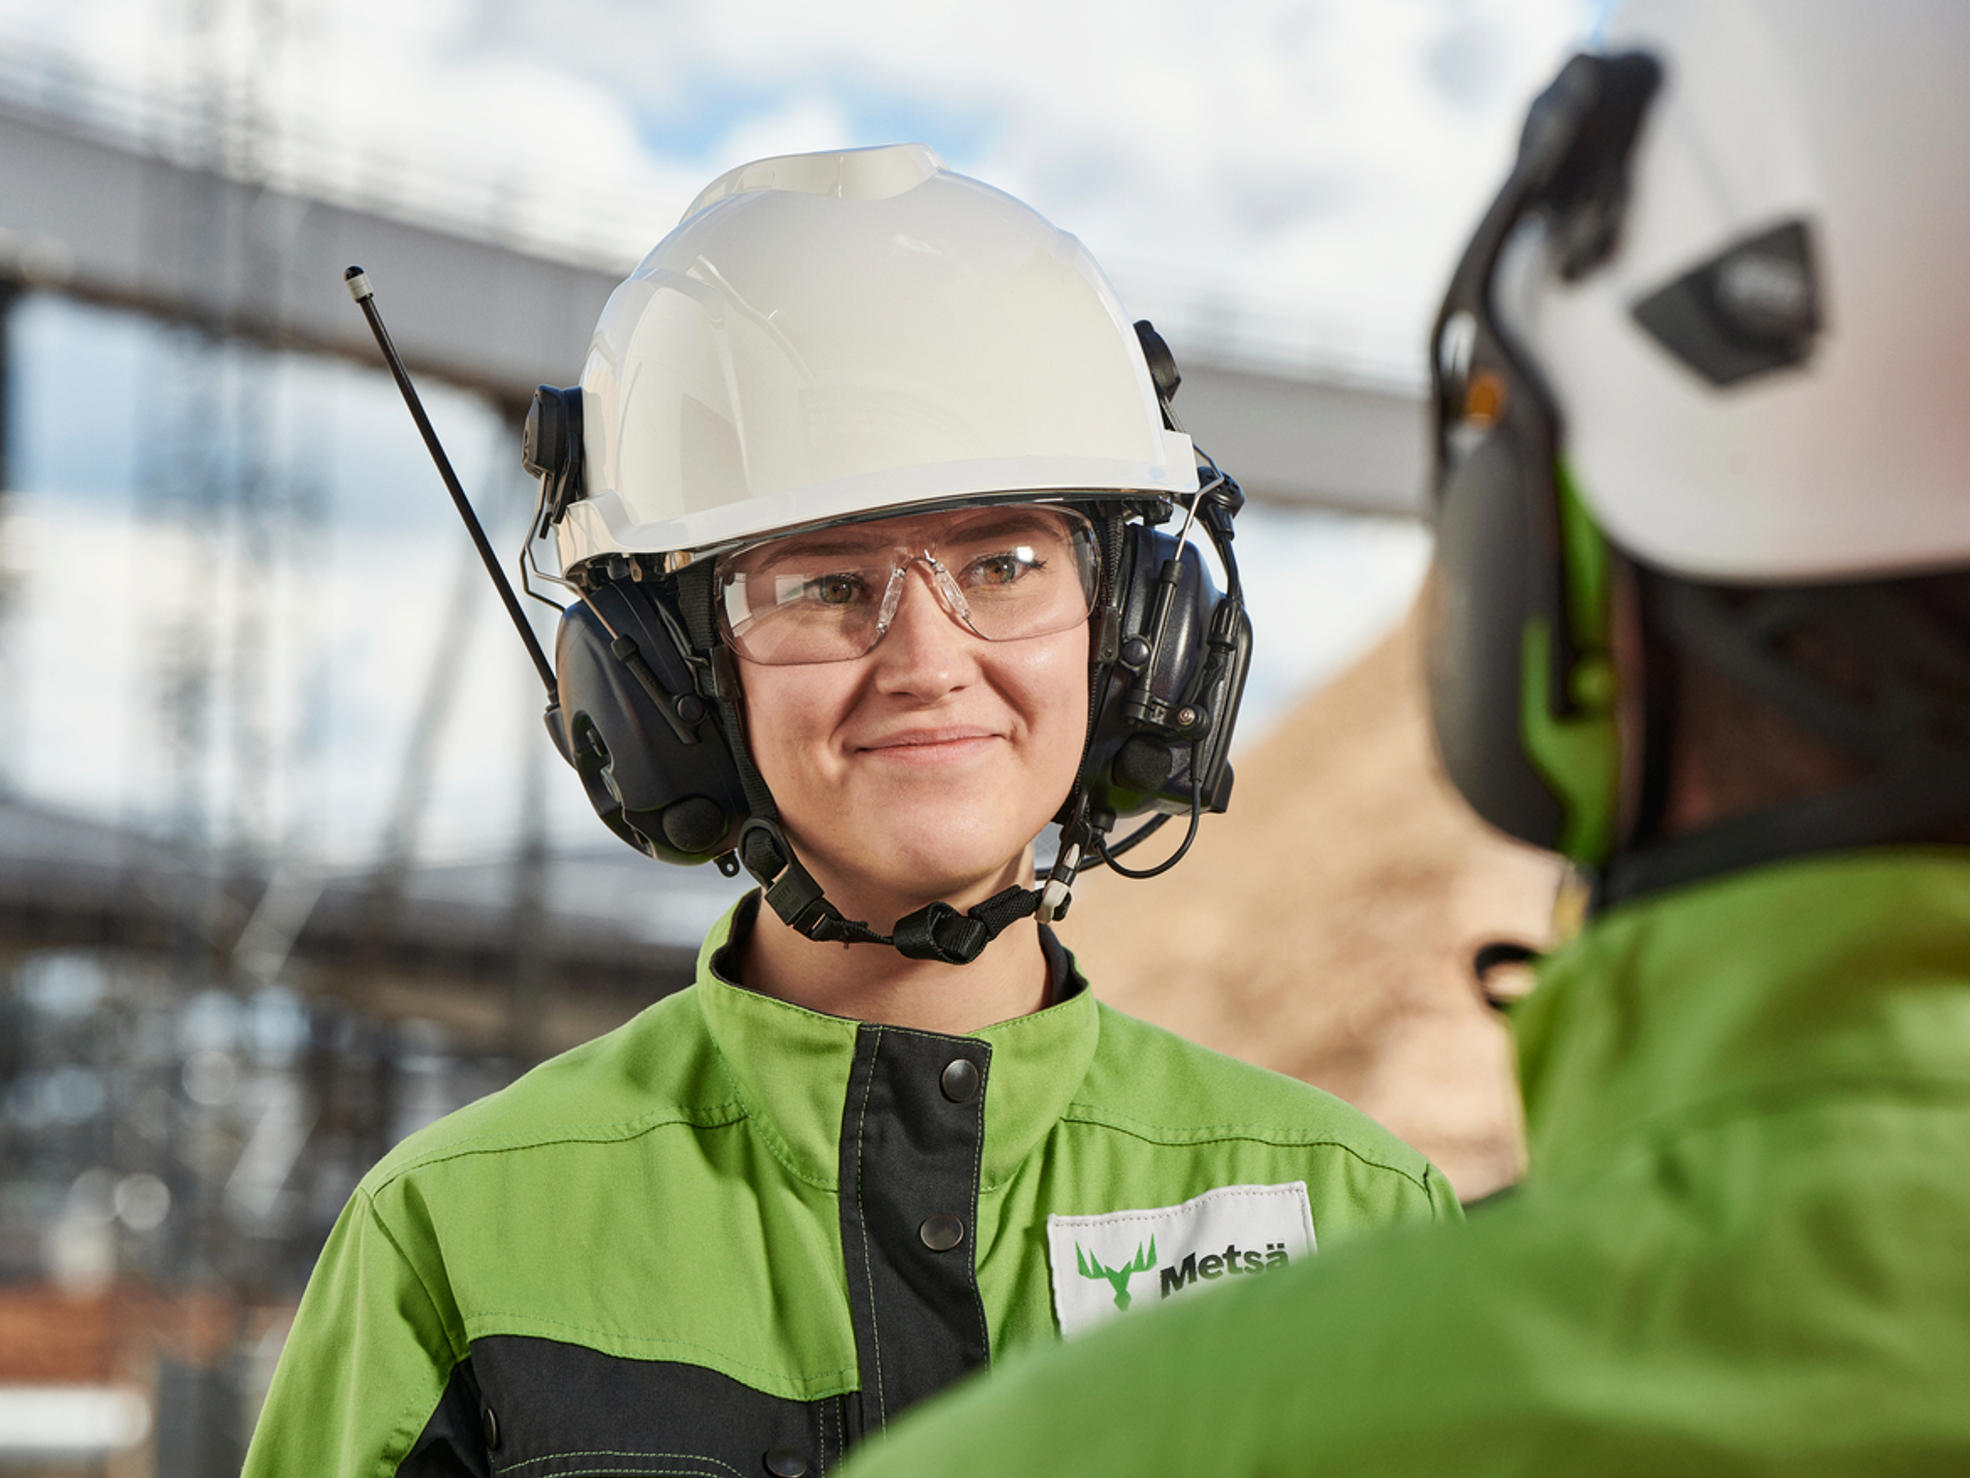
top-left (1424, 422), bottom-right (1564, 847)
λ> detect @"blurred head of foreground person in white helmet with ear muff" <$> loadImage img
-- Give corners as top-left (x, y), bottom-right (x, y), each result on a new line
top-left (1428, 0), bottom-right (1970, 903)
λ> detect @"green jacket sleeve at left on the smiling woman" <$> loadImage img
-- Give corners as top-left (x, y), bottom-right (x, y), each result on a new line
top-left (244, 1190), bottom-right (465, 1478)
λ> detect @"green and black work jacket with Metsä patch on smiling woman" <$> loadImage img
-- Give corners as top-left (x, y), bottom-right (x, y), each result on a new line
top-left (246, 899), bottom-right (1460, 1478)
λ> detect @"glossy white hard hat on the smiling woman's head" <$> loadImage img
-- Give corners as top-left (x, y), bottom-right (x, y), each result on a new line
top-left (558, 144), bottom-right (1198, 570)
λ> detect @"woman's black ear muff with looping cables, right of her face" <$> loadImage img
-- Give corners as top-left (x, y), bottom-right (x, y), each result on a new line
top-left (1084, 524), bottom-right (1251, 826)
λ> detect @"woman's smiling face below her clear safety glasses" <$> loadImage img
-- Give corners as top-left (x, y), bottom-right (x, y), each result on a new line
top-left (739, 514), bottom-right (1087, 926)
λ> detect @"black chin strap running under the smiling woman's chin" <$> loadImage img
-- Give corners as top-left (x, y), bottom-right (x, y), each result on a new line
top-left (678, 560), bottom-right (1087, 966)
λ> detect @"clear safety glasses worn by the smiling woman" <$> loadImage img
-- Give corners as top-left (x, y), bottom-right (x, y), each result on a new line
top-left (717, 504), bottom-right (1099, 666)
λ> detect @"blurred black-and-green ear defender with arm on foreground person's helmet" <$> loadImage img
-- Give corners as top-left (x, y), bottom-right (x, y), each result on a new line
top-left (1428, 53), bottom-right (1661, 863)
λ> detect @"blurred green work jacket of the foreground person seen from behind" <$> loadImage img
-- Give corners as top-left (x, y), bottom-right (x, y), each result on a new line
top-left (849, 847), bottom-right (1970, 1478)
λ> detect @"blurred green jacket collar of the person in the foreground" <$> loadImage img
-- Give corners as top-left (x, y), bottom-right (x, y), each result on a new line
top-left (1513, 847), bottom-right (1970, 1178)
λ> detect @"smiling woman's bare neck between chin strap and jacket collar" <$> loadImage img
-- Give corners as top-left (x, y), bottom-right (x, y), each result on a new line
top-left (739, 859), bottom-right (1048, 1037)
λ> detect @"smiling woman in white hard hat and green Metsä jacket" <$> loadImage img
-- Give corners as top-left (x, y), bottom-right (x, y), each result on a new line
top-left (246, 146), bottom-right (1458, 1478)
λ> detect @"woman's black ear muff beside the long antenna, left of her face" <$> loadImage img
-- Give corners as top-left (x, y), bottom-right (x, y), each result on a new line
top-left (548, 579), bottom-right (747, 863)
